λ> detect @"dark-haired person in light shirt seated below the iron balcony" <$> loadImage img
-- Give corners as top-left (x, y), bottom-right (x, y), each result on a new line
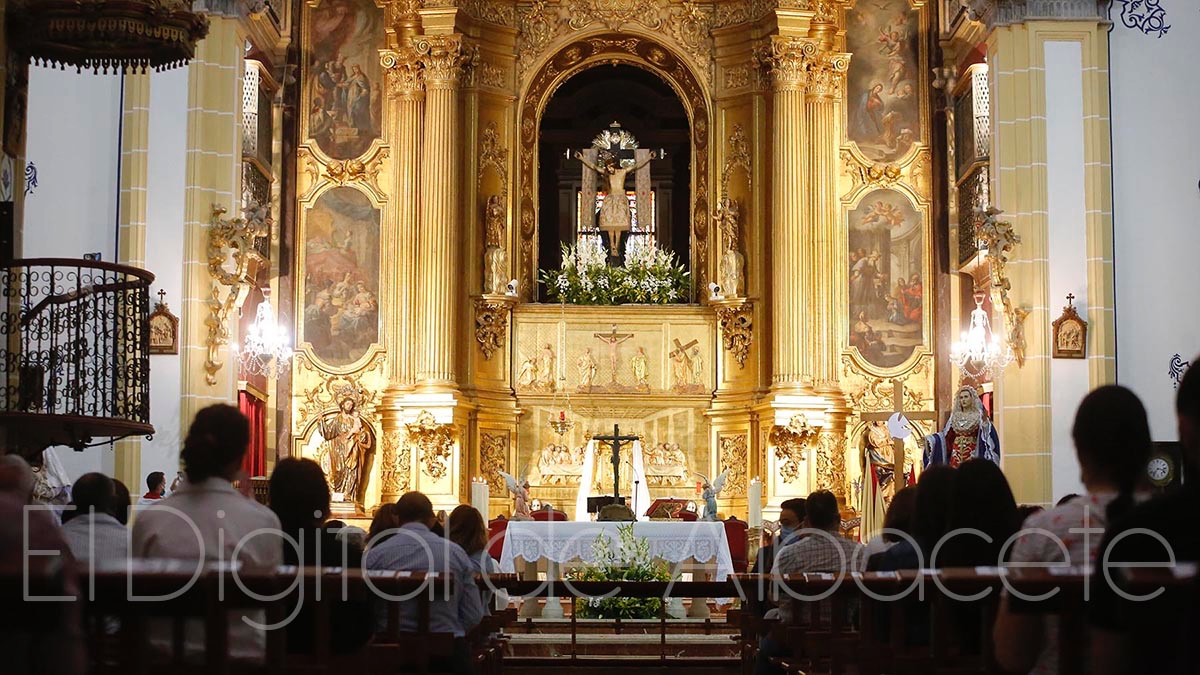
top-left (62, 473), bottom-right (130, 563)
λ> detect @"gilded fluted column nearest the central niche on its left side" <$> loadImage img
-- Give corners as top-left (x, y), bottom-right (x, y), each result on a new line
top-left (415, 35), bottom-right (464, 392)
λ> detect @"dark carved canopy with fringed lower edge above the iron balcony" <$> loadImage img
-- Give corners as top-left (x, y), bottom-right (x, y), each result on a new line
top-left (11, 0), bottom-right (209, 73)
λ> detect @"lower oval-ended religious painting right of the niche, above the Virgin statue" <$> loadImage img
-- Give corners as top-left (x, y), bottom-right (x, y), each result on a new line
top-left (847, 190), bottom-right (925, 368)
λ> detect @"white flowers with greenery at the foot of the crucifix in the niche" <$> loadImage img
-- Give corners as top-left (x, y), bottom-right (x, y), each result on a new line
top-left (541, 237), bottom-right (691, 305)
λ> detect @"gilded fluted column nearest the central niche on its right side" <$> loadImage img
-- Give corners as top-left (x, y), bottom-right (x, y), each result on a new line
top-left (764, 36), bottom-right (816, 390)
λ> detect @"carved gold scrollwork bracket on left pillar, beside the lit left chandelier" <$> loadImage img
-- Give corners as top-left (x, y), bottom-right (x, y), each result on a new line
top-left (204, 204), bottom-right (274, 386)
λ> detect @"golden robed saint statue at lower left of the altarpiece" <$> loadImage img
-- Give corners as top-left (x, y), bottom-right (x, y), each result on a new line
top-left (318, 396), bottom-right (374, 504)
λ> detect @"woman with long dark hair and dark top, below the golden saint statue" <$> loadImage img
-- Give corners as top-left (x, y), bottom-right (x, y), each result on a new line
top-left (269, 458), bottom-right (374, 653)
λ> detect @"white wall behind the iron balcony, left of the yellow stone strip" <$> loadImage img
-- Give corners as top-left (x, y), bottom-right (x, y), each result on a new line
top-left (22, 66), bottom-right (121, 479)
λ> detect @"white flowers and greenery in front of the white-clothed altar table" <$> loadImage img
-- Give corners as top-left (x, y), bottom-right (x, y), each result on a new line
top-left (566, 524), bottom-right (671, 619)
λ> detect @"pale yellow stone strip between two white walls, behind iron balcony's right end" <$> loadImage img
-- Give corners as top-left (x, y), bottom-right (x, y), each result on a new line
top-left (114, 72), bottom-right (150, 485)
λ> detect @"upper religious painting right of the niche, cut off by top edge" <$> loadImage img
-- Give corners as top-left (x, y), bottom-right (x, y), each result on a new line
top-left (846, 0), bottom-right (922, 162)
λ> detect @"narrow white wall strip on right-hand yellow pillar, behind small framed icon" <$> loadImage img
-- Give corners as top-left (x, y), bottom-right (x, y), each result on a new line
top-left (1042, 41), bottom-right (1091, 501)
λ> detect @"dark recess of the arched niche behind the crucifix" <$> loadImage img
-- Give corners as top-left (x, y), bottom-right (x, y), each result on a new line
top-left (536, 64), bottom-right (691, 300)
